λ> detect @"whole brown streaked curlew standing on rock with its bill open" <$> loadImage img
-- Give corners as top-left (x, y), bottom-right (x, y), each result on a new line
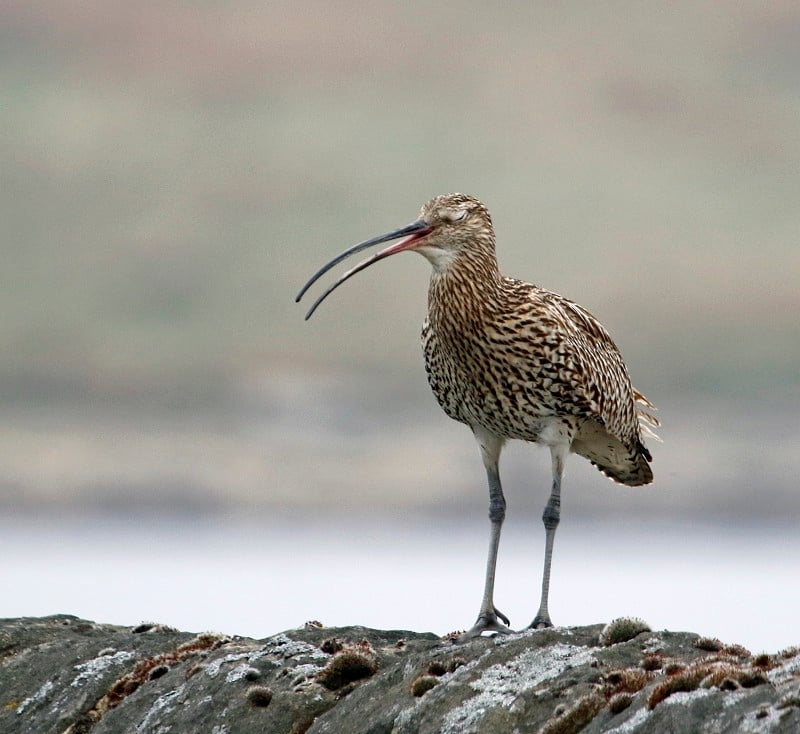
top-left (296, 194), bottom-right (658, 639)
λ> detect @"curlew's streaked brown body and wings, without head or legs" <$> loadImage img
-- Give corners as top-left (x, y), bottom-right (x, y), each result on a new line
top-left (422, 274), bottom-right (657, 486)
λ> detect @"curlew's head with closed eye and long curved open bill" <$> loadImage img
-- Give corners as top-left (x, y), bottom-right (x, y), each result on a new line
top-left (295, 194), bottom-right (494, 319)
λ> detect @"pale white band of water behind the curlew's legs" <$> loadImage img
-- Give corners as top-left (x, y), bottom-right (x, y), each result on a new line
top-left (0, 514), bottom-right (800, 652)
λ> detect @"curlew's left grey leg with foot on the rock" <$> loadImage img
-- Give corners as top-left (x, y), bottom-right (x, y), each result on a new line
top-left (459, 430), bottom-right (510, 641)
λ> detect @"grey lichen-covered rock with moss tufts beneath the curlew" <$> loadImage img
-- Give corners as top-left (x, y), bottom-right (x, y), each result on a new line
top-left (0, 616), bottom-right (800, 734)
